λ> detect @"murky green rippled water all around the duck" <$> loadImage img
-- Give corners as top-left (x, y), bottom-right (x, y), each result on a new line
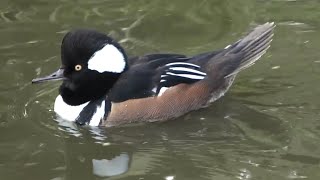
top-left (0, 0), bottom-right (320, 180)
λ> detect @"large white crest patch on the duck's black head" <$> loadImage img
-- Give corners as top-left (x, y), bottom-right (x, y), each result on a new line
top-left (88, 44), bottom-right (126, 73)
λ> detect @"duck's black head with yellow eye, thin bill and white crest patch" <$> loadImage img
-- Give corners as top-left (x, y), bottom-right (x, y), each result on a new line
top-left (32, 29), bottom-right (128, 105)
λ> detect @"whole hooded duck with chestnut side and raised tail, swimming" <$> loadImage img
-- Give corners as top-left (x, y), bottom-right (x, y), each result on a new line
top-left (32, 22), bottom-right (275, 127)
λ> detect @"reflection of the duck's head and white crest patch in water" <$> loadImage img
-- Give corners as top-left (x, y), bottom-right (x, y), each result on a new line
top-left (63, 127), bottom-right (132, 179)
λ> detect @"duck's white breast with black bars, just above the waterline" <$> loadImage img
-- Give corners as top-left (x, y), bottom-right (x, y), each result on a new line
top-left (54, 95), bottom-right (108, 126)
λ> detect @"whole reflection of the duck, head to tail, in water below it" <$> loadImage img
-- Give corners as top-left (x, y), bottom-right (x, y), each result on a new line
top-left (52, 97), bottom-right (288, 179)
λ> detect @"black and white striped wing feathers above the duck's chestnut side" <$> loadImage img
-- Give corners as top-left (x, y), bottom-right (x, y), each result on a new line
top-left (156, 62), bottom-right (207, 96)
